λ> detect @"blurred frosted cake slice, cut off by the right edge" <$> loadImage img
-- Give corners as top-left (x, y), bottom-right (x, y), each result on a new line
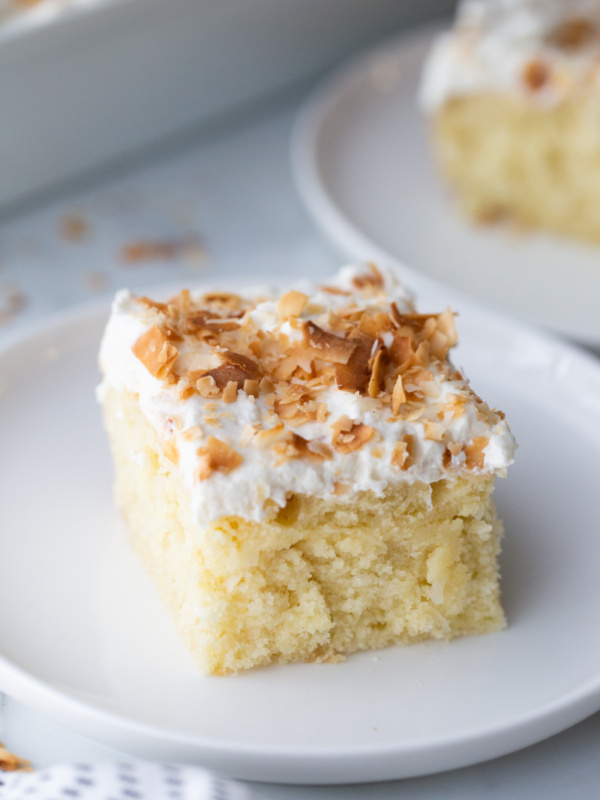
top-left (421, 0), bottom-right (600, 242)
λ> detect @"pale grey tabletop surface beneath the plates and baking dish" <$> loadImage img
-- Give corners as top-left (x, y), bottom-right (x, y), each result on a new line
top-left (0, 97), bottom-right (600, 800)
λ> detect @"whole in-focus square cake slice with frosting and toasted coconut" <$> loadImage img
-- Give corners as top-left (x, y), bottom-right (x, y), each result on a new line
top-left (99, 266), bottom-right (515, 674)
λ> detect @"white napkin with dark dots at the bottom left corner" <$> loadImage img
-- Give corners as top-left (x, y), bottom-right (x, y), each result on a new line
top-left (0, 761), bottom-right (258, 800)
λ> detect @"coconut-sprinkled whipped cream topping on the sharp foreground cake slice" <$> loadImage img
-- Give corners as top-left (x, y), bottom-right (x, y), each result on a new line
top-left (98, 265), bottom-right (516, 524)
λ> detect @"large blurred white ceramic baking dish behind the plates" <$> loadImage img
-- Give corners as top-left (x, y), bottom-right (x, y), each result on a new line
top-left (0, 0), bottom-right (452, 214)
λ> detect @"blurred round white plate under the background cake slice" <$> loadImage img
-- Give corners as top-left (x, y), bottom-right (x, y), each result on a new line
top-left (293, 26), bottom-right (600, 346)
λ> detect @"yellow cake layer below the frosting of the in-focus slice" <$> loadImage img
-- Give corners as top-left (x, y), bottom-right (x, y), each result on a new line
top-left (104, 390), bottom-right (504, 674)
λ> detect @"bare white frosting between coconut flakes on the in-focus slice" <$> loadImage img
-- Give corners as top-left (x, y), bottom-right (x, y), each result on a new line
top-left (99, 267), bottom-right (515, 523)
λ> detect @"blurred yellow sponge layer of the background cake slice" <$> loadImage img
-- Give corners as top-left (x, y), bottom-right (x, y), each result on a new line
top-left (433, 91), bottom-right (600, 242)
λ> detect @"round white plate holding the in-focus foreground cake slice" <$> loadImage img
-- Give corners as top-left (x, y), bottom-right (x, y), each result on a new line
top-left (0, 298), bottom-right (600, 783)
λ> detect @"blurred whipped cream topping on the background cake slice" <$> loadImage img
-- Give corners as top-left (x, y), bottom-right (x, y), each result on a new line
top-left (419, 0), bottom-right (600, 112)
